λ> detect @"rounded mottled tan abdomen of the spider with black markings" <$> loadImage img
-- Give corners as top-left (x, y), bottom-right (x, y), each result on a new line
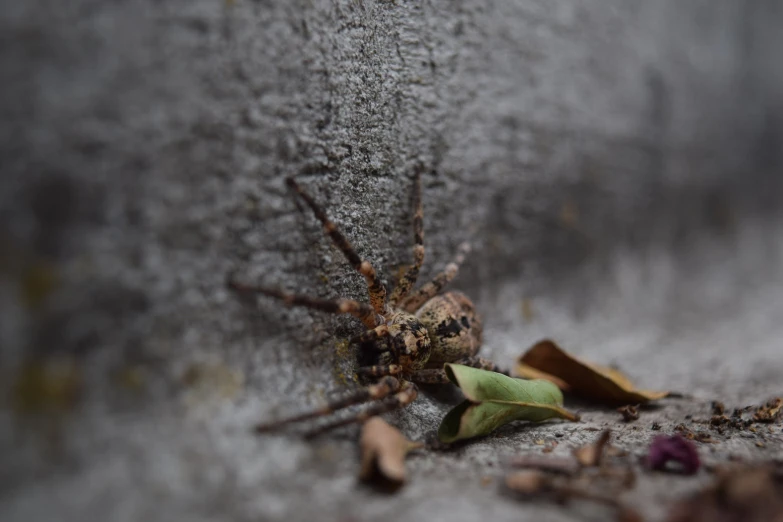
top-left (416, 292), bottom-right (483, 368)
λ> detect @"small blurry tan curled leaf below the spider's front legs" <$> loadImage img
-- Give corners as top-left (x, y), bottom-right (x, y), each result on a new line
top-left (359, 417), bottom-right (423, 487)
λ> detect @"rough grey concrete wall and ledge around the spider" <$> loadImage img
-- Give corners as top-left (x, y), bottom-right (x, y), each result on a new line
top-left (0, 0), bottom-right (783, 521)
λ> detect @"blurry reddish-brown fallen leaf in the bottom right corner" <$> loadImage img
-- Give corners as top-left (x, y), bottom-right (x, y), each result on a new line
top-left (667, 466), bottom-right (783, 522)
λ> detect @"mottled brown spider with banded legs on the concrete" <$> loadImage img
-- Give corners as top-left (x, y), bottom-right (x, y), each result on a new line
top-left (228, 170), bottom-right (507, 435)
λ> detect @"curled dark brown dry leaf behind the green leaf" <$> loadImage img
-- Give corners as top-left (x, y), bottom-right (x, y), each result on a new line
top-left (517, 339), bottom-right (669, 404)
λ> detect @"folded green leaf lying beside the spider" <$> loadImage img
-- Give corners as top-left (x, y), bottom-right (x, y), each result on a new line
top-left (438, 364), bottom-right (578, 443)
